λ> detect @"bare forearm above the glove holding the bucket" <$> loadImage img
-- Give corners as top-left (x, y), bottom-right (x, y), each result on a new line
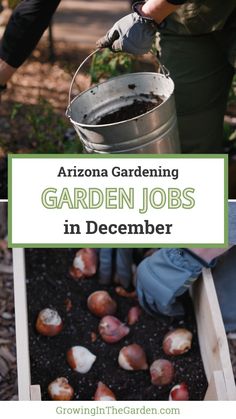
top-left (140, 0), bottom-right (185, 23)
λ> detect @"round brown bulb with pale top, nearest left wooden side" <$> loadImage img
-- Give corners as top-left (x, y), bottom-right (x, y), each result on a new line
top-left (35, 308), bottom-right (63, 336)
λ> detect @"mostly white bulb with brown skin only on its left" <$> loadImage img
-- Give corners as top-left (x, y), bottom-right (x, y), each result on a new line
top-left (67, 346), bottom-right (96, 374)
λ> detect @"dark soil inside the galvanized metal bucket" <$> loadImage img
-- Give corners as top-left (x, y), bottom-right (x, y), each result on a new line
top-left (96, 95), bottom-right (163, 125)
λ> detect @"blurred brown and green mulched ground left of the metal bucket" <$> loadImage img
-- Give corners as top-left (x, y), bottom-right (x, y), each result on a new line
top-left (0, 41), bottom-right (90, 199)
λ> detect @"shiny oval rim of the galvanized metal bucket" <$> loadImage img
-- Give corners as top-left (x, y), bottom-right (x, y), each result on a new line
top-left (66, 71), bottom-right (175, 128)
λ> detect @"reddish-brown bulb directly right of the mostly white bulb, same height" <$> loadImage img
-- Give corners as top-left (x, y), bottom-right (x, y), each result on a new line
top-left (118, 343), bottom-right (148, 371)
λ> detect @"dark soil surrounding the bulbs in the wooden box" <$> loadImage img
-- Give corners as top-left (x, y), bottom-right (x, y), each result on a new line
top-left (24, 249), bottom-right (207, 400)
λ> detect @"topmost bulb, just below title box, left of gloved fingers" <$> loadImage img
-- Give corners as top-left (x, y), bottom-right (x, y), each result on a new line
top-left (70, 248), bottom-right (98, 279)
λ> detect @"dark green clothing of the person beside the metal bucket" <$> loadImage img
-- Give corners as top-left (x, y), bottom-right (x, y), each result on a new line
top-left (160, 0), bottom-right (236, 153)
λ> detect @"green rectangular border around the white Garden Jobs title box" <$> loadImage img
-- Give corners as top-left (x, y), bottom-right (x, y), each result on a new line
top-left (8, 154), bottom-right (228, 248)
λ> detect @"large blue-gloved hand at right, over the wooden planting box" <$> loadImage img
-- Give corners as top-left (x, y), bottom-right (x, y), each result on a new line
top-left (136, 249), bottom-right (215, 316)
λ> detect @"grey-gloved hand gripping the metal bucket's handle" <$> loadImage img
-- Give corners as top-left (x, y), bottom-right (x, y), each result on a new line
top-left (97, 12), bottom-right (157, 55)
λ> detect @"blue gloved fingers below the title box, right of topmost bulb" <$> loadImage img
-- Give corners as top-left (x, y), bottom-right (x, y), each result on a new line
top-left (98, 249), bottom-right (133, 288)
